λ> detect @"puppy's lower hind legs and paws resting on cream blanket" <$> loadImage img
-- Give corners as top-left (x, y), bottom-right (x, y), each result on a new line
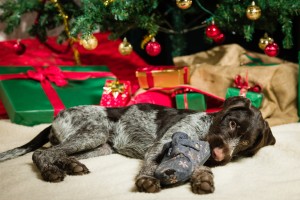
top-left (32, 129), bottom-right (108, 182)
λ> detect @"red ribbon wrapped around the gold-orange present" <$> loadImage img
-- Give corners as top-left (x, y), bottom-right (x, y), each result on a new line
top-left (138, 67), bottom-right (189, 88)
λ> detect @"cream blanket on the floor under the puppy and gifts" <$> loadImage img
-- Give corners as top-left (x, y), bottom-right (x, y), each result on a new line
top-left (0, 120), bottom-right (300, 200)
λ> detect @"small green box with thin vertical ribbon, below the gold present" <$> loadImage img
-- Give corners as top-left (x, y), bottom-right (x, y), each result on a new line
top-left (175, 92), bottom-right (207, 111)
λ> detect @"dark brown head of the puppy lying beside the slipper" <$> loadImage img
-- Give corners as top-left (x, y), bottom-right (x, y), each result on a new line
top-left (206, 96), bottom-right (276, 166)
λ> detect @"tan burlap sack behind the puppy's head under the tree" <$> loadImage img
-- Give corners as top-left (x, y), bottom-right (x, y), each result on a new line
top-left (174, 44), bottom-right (298, 126)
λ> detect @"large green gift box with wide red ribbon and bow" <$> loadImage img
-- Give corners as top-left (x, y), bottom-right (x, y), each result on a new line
top-left (0, 66), bottom-right (115, 126)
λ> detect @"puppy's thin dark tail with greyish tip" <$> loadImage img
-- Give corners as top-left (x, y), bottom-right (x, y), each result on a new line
top-left (0, 126), bottom-right (51, 162)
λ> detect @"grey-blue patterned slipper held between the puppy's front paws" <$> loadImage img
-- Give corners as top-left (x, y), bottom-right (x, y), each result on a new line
top-left (154, 132), bottom-right (210, 186)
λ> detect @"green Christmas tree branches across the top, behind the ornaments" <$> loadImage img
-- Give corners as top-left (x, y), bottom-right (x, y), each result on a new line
top-left (0, 0), bottom-right (300, 52)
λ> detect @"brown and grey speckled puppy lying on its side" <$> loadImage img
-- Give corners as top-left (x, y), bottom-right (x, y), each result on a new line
top-left (0, 97), bottom-right (275, 194)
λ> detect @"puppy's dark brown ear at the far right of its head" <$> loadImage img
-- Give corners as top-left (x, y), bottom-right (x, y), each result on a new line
top-left (248, 121), bottom-right (276, 156)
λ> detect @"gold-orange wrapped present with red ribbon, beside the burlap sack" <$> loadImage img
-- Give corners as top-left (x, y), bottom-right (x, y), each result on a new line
top-left (136, 66), bottom-right (189, 89)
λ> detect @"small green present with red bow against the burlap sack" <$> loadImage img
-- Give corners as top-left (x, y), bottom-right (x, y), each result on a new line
top-left (225, 74), bottom-right (263, 108)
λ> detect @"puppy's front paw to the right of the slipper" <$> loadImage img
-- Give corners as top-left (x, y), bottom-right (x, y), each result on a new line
top-left (191, 166), bottom-right (215, 194)
